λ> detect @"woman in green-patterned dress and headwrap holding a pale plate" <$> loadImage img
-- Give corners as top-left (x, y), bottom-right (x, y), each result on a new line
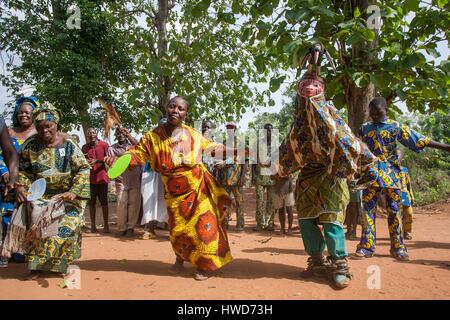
top-left (16, 103), bottom-right (90, 279)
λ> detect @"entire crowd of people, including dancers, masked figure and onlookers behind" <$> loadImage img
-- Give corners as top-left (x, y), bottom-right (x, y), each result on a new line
top-left (0, 52), bottom-right (450, 288)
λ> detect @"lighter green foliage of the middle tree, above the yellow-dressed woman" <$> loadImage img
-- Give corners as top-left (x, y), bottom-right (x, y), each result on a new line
top-left (115, 0), bottom-right (268, 124)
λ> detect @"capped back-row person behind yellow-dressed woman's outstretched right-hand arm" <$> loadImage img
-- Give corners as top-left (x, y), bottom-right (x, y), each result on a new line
top-left (215, 122), bottom-right (246, 232)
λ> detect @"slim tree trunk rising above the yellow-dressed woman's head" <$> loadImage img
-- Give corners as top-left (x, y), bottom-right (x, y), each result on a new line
top-left (156, 0), bottom-right (171, 114)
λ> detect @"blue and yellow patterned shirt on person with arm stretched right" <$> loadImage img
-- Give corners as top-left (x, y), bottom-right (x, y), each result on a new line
top-left (359, 118), bottom-right (430, 189)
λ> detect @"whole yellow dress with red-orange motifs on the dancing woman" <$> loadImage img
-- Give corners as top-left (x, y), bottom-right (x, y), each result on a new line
top-left (128, 125), bottom-right (232, 271)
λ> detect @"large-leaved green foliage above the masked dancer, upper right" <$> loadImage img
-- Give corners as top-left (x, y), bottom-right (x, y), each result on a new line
top-left (241, 0), bottom-right (450, 113)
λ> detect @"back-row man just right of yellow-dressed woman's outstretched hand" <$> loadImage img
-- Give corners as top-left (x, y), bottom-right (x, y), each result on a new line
top-left (252, 123), bottom-right (275, 231)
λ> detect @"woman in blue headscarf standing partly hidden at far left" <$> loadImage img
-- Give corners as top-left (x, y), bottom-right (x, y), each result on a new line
top-left (0, 96), bottom-right (40, 267)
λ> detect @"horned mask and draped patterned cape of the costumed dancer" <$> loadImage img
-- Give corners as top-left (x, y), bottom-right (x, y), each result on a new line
top-left (284, 43), bottom-right (375, 182)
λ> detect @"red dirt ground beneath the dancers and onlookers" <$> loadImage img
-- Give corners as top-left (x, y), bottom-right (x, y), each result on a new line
top-left (0, 189), bottom-right (450, 300)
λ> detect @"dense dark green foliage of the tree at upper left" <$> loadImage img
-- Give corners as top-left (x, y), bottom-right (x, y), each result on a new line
top-left (0, 0), bottom-right (132, 128)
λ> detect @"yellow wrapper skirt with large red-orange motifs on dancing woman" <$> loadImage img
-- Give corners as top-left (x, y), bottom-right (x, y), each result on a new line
top-left (162, 164), bottom-right (232, 271)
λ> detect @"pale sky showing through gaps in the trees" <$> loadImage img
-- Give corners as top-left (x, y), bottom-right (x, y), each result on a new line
top-left (0, 5), bottom-right (450, 142)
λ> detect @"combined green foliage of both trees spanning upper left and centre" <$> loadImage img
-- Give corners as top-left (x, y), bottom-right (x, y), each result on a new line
top-left (0, 0), bottom-right (268, 130)
